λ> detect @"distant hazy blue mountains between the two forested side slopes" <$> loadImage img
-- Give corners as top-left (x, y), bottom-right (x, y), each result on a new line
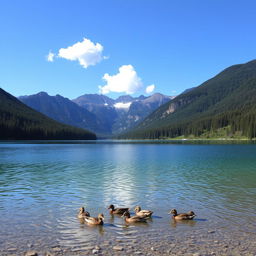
top-left (19, 92), bottom-right (173, 137)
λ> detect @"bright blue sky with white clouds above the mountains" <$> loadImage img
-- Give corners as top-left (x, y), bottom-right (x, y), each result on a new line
top-left (0, 0), bottom-right (256, 99)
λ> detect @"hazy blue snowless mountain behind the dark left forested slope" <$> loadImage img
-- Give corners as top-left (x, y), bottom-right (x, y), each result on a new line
top-left (19, 92), bottom-right (104, 133)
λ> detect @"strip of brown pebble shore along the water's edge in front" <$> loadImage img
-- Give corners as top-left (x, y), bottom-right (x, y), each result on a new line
top-left (0, 230), bottom-right (256, 256)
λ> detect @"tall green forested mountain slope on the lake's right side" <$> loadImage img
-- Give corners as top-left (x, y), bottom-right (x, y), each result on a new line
top-left (121, 60), bottom-right (256, 139)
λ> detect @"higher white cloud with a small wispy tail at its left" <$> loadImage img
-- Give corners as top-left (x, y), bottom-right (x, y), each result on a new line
top-left (47, 38), bottom-right (106, 68)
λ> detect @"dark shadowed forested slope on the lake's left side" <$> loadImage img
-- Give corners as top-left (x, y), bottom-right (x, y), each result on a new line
top-left (0, 88), bottom-right (96, 140)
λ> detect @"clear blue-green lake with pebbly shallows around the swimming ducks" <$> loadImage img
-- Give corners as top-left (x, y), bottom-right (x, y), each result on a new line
top-left (0, 141), bottom-right (256, 255)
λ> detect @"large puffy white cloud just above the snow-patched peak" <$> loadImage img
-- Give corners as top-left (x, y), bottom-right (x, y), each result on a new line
top-left (99, 65), bottom-right (142, 94)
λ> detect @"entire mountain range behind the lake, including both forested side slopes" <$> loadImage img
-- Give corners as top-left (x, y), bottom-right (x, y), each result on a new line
top-left (0, 60), bottom-right (256, 139)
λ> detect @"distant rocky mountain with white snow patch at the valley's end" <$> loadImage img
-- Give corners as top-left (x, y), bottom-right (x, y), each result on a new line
top-left (73, 93), bottom-right (172, 135)
